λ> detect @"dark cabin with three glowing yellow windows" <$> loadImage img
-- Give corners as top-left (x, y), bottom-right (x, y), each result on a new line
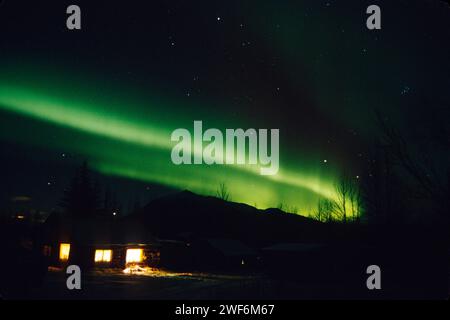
top-left (41, 214), bottom-right (161, 269)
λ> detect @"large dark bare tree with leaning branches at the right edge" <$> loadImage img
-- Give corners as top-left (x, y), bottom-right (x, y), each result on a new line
top-left (376, 103), bottom-right (450, 217)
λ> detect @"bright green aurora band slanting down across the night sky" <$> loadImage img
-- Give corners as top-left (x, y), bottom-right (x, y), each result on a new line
top-left (0, 69), bottom-right (336, 213)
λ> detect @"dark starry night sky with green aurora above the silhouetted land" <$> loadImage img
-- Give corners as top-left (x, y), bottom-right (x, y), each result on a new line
top-left (0, 0), bottom-right (450, 214)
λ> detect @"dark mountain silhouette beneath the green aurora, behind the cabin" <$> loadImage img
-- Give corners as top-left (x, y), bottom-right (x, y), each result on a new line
top-left (127, 191), bottom-right (325, 245)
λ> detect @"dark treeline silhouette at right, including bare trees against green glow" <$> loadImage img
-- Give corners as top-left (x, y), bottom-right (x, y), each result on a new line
top-left (310, 101), bottom-right (450, 226)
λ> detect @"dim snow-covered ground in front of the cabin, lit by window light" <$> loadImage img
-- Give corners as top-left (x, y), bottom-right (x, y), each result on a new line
top-left (27, 269), bottom-right (268, 300)
